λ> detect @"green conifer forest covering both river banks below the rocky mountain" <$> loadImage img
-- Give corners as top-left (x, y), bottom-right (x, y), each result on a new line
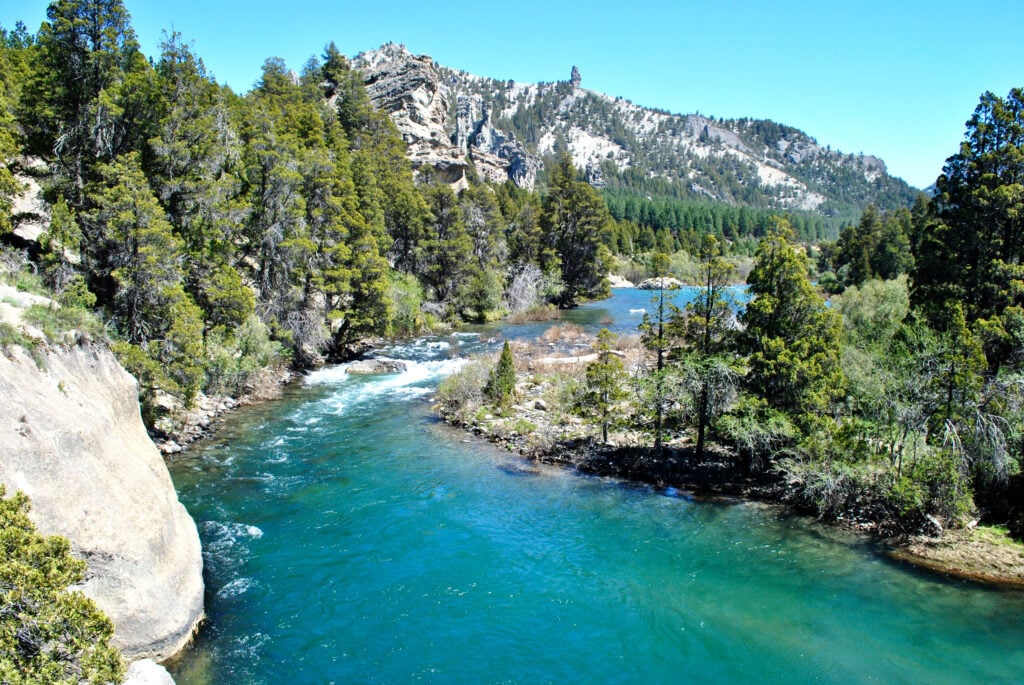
top-left (0, 0), bottom-right (1024, 530)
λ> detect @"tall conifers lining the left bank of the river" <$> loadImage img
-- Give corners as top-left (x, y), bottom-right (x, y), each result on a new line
top-left (0, 0), bottom-right (611, 420)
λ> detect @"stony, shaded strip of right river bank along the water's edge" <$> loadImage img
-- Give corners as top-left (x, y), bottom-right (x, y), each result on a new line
top-left (435, 327), bottom-right (1024, 590)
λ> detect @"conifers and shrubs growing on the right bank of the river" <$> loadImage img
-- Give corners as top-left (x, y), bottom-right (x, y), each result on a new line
top-left (462, 89), bottom-right (1024, 534)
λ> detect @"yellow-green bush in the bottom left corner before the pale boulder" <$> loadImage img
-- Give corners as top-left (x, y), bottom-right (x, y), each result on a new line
top-left (0, 485), bottom-right (125, 685)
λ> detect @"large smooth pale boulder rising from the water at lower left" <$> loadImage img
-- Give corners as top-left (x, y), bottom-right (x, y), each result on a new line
top-left (0, 346), bottom-right (203, 660)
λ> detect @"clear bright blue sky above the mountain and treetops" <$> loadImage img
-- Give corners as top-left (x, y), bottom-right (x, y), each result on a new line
top-left (0, 0), bottom-right (1024, 187)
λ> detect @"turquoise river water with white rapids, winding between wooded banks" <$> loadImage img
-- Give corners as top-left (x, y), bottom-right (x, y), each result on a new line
top-left (171, 291), bottom-right (1024, 685)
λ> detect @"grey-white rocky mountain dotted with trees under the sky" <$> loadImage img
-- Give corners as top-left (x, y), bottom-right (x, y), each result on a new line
top-left (353, 43), bottom-right (915, 216)
